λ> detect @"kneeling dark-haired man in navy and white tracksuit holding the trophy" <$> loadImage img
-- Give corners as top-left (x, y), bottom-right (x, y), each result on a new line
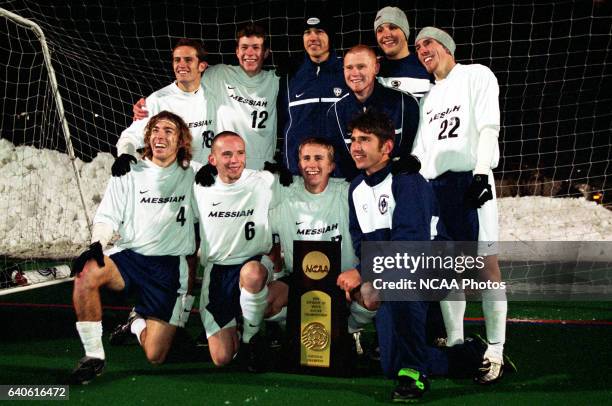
top-left (340, 111), bottom-right (484, 401)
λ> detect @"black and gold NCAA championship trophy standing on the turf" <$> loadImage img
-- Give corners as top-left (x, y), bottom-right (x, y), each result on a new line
top-left (287, 241), bottom-right (351, 376)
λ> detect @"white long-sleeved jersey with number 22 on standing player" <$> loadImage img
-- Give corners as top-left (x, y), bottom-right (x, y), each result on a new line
top-left (413, 64), bottom-right (500, 179)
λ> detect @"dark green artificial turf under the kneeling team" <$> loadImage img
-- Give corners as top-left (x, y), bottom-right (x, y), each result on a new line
top-left (0, 283), bottom-right (612, 406)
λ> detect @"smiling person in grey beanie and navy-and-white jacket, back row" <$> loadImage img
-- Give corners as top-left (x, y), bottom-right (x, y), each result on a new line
top-left (374, 6), bottom-right (431, 100)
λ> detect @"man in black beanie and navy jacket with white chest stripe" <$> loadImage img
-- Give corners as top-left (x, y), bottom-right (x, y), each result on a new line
top-left (278, 10), bottom-right (348, 175)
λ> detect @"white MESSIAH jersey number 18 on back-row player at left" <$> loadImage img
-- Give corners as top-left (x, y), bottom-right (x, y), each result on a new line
top-left (117, 82), bottom-right (215, 163)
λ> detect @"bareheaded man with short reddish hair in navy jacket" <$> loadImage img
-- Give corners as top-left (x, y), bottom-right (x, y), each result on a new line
top-left (325, 45), bottom-right (419, 178)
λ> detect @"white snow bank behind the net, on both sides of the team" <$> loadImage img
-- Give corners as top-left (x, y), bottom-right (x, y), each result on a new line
top-left (0, 139), bottom-right (612, 258)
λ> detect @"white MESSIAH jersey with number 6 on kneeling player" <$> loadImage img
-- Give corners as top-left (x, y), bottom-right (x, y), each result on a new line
top-left (193, 169), bottom-right (279, 266)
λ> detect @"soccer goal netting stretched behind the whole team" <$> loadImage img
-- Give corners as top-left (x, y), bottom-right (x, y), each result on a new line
top-left (0, 0), bottom-right (612, 292)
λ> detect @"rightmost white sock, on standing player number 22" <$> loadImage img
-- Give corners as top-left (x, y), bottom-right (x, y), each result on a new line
top-left (482, 290), bottom-right (508, 359)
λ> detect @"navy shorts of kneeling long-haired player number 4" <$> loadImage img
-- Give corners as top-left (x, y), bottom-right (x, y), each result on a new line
top-left (110, 250), bottom-right (180, 322)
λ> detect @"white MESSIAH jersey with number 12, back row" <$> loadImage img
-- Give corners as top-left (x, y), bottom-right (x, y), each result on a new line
top-left (202, 64), bottom-right (278, 169)
